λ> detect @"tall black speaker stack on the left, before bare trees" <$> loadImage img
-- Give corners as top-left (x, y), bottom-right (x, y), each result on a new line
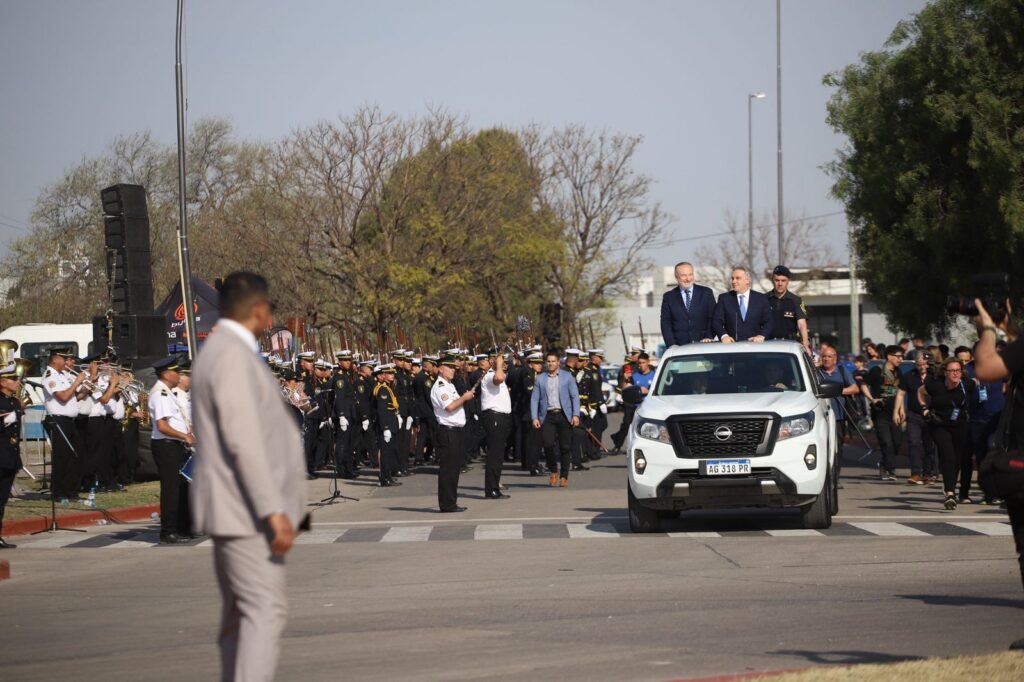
top-left (93, 184), bottom-right (167, 361)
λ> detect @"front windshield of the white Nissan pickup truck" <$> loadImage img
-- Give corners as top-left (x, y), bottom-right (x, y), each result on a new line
top-left (652, 352), bottom-right (804, 395)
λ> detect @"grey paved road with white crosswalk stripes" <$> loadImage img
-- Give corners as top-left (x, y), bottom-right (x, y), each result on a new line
top-left (0, 411), bottom-right (1024, 681)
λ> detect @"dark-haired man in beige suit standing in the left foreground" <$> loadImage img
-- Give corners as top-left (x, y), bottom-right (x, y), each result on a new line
top-left (191, 272), bottom-right (305, 680)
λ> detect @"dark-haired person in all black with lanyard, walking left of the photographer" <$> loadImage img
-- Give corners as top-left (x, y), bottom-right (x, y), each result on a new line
top-left (918, 357), bottom-right (977, 511)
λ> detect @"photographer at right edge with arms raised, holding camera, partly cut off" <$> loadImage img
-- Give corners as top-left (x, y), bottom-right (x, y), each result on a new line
top-left (966, 275), bottom-right (1024, 649)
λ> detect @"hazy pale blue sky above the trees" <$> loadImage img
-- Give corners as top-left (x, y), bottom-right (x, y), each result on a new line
top-left (0, 0), bottom-right (925, 263)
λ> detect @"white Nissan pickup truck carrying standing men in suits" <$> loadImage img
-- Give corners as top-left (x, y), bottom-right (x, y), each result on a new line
top-left (627, 341), bottom-right (842, 532)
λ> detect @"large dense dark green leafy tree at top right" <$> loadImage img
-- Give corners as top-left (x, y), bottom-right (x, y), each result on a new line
top-left (824, 0), bottom-right (1024, 334)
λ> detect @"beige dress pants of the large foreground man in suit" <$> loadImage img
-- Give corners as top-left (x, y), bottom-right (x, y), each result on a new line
top-left (213, 535), bottom-right (288, 682)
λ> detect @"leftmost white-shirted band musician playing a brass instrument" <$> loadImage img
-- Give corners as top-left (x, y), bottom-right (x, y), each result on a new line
top-left (42, 348), bottom-right (85, 503)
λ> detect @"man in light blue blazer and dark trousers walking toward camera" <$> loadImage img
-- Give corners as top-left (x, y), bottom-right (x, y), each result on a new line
top-left (529, 351), bottom-right (580, 487)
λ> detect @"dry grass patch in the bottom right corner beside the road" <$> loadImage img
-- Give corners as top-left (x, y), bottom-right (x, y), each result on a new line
top-left (756, 647), bottom-right (1024, 682)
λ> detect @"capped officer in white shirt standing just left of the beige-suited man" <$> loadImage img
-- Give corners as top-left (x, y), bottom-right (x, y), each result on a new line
top-left (150, 356), bottom-right (193, 545)
